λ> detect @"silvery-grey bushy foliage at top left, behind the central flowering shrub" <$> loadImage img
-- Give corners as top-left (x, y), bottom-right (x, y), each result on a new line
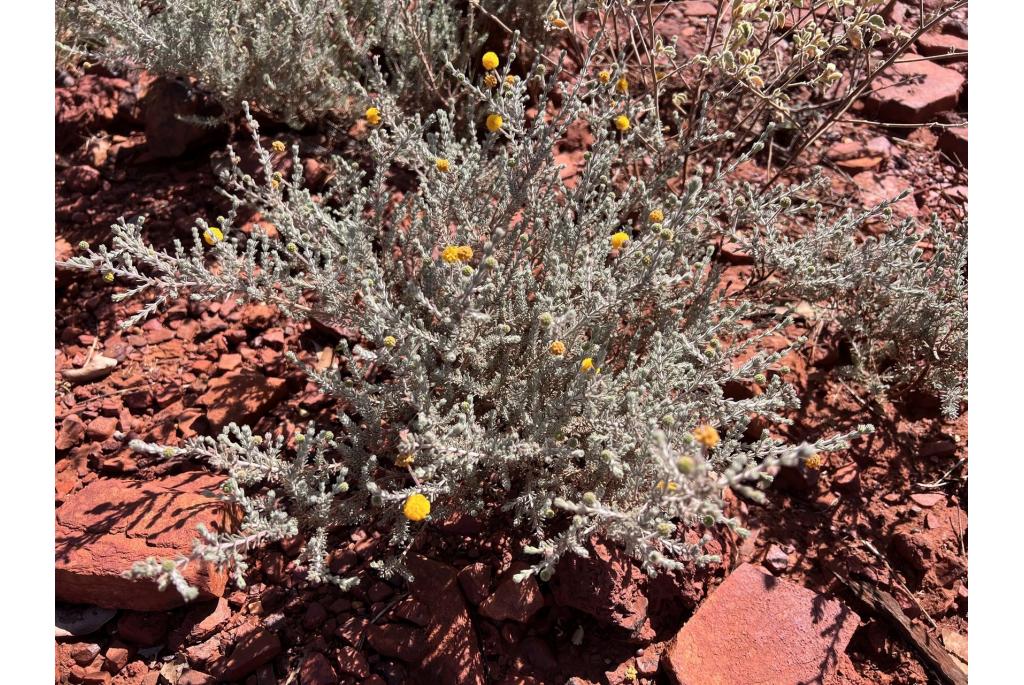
top-left (57, 0), bottom-right (548, 127)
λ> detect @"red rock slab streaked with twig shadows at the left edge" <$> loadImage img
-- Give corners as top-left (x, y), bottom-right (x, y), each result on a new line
top-left (55, 472), bottom-right (229, 611)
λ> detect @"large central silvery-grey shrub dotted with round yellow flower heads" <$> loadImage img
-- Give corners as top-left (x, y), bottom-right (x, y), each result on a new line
top-left (66, 39), bottom-right (884, 587)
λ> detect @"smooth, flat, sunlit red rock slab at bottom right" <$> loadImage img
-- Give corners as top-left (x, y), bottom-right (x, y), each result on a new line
top-left (662, 564), bottom-right (860, 685)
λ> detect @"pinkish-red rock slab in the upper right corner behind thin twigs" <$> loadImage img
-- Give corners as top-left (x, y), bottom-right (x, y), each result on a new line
top-left (865, 60), bottom-right (967, 124)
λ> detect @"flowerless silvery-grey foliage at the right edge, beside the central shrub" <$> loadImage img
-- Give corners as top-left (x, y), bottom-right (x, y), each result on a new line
top-left (731, 189), bottom-right (968, 419)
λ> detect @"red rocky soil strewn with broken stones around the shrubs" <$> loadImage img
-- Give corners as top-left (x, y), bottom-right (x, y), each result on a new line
top-left (54, 2), bottom-right (968, 685)
